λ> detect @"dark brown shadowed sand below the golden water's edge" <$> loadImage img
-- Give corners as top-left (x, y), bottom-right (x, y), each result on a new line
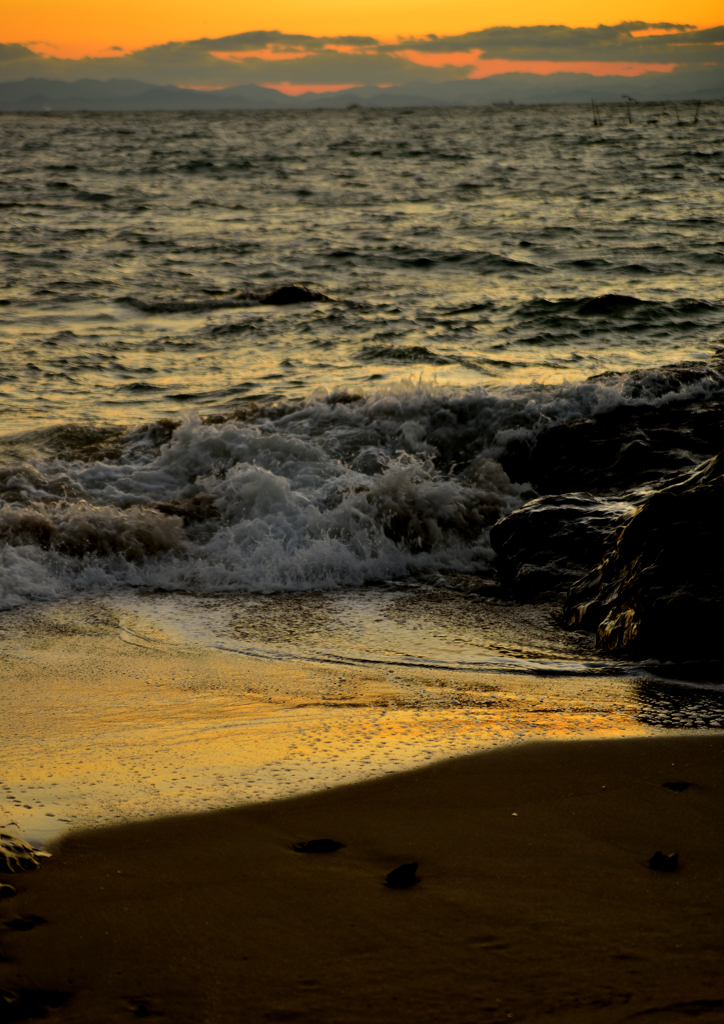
top-left (0, 732), bottom-right (724, 1024)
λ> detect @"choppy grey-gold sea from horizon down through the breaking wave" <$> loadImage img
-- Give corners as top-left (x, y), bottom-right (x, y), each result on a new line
top-left (0, 103), bottom-right (724, 673)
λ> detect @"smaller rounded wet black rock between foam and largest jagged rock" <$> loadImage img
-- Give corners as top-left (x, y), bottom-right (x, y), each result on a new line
top-left (491, 494), bottom-right (634, 601)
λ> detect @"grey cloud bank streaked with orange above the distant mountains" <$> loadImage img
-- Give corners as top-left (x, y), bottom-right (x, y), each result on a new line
top-left (0, 22), bottom-right (724, 88)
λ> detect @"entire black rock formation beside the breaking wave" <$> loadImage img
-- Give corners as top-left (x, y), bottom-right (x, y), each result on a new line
top-left (491, 358), bottom-right (724, 662)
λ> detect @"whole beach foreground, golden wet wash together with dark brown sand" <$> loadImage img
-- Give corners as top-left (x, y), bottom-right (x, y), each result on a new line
top-left (5, 602), bottom-right (724, 1024)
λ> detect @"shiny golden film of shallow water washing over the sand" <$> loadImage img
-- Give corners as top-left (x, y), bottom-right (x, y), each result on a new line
top-left (0, 606), bottom-right (651, 842)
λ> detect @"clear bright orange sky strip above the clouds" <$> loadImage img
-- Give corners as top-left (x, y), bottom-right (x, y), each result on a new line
top-left (0, 0), bottom-right (722, 57)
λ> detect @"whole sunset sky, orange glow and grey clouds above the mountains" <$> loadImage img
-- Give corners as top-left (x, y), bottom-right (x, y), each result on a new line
top-left (0, 0), bottom-right (724, 91)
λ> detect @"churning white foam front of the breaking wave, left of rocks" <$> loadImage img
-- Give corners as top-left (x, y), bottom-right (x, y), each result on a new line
top-left (0, 420), bottom-right (522, 607)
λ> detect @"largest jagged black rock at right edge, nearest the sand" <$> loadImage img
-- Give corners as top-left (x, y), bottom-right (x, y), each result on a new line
top-left (563, 453), bottom-right (724, 660)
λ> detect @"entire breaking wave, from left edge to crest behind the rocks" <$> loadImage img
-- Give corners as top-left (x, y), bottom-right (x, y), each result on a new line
top-left (0, 359), bottom-right (724, 607)
